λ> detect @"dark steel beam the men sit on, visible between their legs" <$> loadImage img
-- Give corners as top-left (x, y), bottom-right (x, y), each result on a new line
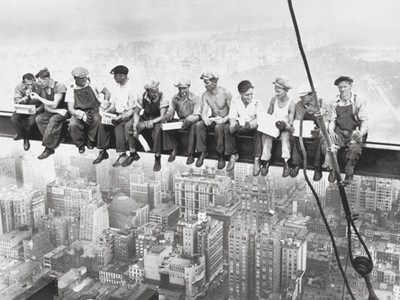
top-left (0, 111), bottom-right (400, 179)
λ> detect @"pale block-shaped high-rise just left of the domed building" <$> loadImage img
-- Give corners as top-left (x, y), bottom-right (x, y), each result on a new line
top-left (79, 201), bottom-right (109, 241)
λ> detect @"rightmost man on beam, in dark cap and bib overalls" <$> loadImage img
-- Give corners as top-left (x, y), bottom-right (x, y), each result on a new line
top-left (321, 76), bottom-right (368, 183)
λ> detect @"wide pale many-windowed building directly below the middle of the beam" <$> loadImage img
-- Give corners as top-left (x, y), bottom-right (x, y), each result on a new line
top-left (174, 171), bottom-right (234, 219)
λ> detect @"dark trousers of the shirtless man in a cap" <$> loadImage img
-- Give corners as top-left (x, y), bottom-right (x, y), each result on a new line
top-left (196, 121), bottom-right (238, 155)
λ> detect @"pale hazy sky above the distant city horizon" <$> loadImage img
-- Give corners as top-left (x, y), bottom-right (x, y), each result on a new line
top-left (0, 0), bottom-right (400, 43)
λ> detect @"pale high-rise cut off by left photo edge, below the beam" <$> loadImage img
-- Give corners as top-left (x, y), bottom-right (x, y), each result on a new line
top-left (0, 185), bottom-right (45, 232)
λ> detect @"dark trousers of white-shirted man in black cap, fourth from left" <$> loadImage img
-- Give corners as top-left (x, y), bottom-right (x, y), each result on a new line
top-left (97, 120), bottom-right (128, 153)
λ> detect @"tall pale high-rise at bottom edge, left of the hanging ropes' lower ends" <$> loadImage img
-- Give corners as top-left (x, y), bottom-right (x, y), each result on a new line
top-left (281, 238), bottom-right (307, 290)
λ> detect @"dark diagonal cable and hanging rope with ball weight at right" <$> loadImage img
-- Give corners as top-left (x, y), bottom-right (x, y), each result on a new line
top-left (288, 0), bottom-right (378, 300)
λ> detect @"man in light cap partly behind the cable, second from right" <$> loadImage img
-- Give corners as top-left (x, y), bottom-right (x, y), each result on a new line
top-left (290, 84), bottom-right (323, 181)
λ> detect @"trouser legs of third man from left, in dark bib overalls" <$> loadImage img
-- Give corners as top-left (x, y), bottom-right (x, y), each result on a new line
top-left (69, 111), bottom-right (101, 147)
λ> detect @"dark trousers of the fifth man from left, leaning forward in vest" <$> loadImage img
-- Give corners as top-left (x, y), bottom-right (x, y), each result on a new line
top-left (125, 119), bottom-right (162, 155)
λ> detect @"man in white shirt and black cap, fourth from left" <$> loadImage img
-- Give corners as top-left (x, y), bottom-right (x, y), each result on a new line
top-left (93, 65), bottom-right (139, 167)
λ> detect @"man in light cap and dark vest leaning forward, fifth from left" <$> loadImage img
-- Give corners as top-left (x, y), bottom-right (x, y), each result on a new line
top-left (123, 80), bottom-right (168, 172)
